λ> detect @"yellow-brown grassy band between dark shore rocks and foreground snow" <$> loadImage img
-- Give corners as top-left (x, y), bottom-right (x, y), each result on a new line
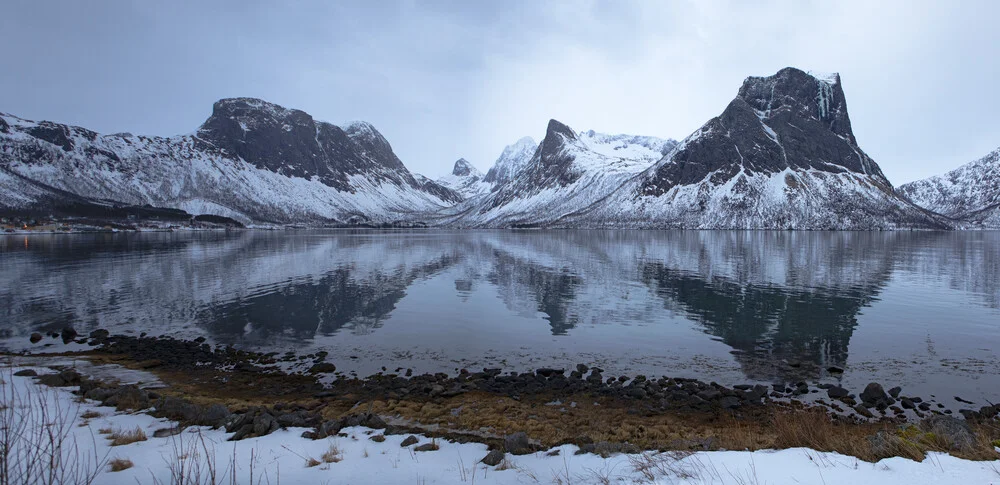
top-left (74, 356), bottom-right (1000, 461)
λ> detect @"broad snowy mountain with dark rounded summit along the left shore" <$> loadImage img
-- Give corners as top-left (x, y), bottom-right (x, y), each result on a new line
top-left (0, 98), bottom-right (462, 222)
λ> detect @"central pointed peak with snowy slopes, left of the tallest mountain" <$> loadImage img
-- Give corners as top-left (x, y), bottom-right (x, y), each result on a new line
top-left (438, 120), bottom-right (671, 227)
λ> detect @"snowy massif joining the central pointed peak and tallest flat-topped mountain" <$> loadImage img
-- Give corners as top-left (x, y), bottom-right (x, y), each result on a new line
top-left (445, 68), bottom-right (953, 229)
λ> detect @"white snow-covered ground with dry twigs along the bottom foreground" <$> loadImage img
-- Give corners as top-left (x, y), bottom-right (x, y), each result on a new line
top-left (0, 369), bottom-right (1000, 485)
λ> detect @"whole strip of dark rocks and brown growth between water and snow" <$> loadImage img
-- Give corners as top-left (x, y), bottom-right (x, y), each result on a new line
top-left (7, 330), bottom-right (1000, 462)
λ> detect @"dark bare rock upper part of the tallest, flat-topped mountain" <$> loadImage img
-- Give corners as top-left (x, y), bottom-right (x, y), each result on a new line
top-left (643, 68), bottom-right (892, 199)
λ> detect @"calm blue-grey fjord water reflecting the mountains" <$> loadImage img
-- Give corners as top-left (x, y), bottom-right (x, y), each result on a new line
top-left (0, 231), bottom-right (1000, 400)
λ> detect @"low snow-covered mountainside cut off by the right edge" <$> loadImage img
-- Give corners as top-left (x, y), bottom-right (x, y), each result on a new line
top-left (899, 148), bottom-right (1000, 228)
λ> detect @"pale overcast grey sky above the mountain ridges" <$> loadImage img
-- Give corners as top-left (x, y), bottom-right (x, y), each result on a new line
top-left (0, 0), bottom-right (1000, 185)
